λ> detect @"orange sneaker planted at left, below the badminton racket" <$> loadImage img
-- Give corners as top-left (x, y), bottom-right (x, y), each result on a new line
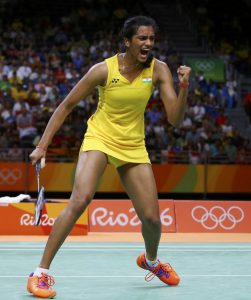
top-left (27, 273), bottom-right (56, 298)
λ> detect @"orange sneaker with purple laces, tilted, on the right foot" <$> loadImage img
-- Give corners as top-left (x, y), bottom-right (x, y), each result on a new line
top-left (137, 253), bottom-right (180, 285)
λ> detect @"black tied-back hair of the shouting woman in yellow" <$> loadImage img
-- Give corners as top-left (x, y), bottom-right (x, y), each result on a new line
top-left (120, 16), bottom-right (159, 68)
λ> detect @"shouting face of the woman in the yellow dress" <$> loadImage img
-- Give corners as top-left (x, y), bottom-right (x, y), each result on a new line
top-left (125, 26), bottom-right (155, 63)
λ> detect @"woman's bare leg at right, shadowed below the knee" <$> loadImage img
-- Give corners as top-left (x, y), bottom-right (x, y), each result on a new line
top-left (118, 164), bottom-right (161, 260)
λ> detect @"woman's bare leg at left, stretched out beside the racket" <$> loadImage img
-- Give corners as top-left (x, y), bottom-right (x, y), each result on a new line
top-left (40, 151), bottom-right (107, 269)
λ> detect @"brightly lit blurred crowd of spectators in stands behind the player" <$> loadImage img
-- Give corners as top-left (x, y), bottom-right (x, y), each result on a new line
top-left (0, 0), bottom-right (251, 164)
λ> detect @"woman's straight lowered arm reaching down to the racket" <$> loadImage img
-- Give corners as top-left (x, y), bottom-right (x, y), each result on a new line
top-left (30, 62), bottom-right (108, 165)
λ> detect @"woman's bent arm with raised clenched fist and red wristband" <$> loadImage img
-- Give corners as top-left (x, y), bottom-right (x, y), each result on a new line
top-left (154, 60), bottom-right (191, 126)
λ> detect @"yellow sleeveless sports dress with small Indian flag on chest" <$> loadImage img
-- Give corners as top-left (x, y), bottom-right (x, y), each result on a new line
top-left (80, 55), bottom-right (155, 167)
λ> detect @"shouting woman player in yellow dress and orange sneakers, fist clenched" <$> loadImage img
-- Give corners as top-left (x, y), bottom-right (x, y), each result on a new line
top-left (27, 16), bottom-right (191, 298)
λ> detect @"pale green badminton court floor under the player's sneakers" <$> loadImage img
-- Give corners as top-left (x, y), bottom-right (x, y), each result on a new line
top-left (0, 243), bottom-right (251, 300)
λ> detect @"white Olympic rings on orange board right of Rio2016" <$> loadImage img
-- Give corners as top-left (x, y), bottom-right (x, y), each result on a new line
top-left (192, 205), bottom-right (244, 230)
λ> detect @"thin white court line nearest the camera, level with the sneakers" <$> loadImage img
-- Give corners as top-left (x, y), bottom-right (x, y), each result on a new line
top-left (0, 274), bottom-right (251, 278)
